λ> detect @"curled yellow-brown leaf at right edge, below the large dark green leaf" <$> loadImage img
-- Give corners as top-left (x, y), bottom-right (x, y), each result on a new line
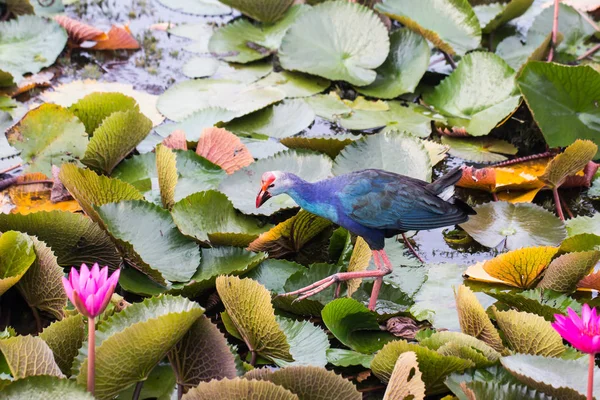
top-left (540, 139), bottom-right (598, 188)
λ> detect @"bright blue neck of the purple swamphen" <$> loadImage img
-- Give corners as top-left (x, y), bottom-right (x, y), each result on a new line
top-left (285, 174), bottom-right (337, 221)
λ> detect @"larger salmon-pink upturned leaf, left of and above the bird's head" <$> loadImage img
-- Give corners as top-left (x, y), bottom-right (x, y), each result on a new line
top-left (196, 128), bottom-right (254, 174)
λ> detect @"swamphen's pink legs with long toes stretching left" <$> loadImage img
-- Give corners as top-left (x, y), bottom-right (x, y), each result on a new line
top-left (279, 250), bottom-right (392, 310)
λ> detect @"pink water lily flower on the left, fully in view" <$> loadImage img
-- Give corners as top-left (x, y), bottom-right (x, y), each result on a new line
top-left (63, 263), bottom-right (120, 318)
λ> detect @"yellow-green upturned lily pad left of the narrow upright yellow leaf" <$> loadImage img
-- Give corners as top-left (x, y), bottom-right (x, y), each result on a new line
top-left (58, 164), bottom-right (143, 227)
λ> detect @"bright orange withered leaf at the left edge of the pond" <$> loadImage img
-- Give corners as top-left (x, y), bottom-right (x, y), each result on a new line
top-left (8, 172), bottom-right (81, 215)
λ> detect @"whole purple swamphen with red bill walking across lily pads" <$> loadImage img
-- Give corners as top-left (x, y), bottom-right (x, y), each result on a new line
top-left (256, 168), bottom-right (475, 310)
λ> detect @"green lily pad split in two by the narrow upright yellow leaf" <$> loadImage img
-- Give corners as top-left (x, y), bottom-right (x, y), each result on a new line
top-left (112, 150), bottom-right (226, 204)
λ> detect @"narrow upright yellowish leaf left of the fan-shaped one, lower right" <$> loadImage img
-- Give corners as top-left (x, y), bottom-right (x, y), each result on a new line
top-left (454, 285), bottom-right (504, 353)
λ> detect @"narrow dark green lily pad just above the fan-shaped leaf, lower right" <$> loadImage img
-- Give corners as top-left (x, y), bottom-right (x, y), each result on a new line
top-left (485, 289), bottom-right (581, 322)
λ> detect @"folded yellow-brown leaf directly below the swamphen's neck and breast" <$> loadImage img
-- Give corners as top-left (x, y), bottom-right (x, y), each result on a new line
top-left (248, 210), bottom-right (331, 258)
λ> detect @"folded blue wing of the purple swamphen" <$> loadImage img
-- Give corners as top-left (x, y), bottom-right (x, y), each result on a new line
top-left (338, 170), bottom-right (466, 231)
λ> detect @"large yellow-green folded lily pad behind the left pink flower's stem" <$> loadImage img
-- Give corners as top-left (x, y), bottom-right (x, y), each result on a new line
top-left (73, 296), bottom-right (204, 399)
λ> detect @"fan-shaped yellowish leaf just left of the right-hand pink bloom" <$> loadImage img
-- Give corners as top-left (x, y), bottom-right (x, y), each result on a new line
top-left (494, 307), bottom-right (565, 357)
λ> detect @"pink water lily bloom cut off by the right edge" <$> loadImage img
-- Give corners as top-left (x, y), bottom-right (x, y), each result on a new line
top-left (552, 304), bottom-right (600, 354)
